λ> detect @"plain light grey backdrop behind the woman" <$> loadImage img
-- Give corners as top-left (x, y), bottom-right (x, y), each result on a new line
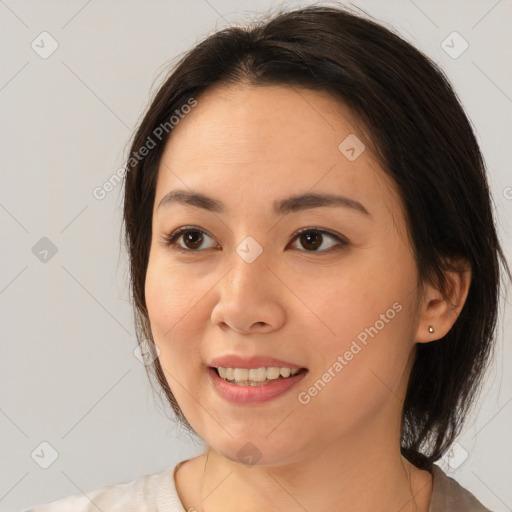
top-left (0, 0), bottom-right (512, 511)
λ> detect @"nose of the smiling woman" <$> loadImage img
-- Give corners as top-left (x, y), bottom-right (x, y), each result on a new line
top-left (211, 249), bottom-right (285, 334)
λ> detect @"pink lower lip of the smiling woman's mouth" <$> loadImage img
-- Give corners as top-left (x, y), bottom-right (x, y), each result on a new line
top-left (208, 368), bottom-right (307, 404)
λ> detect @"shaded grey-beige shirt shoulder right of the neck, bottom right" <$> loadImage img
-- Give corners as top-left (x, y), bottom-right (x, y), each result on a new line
top-left (428, 464), bottom-right (491, 512)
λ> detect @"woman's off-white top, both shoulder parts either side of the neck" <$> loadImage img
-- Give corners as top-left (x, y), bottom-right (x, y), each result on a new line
top-left (22, 461), bottom-right (491, 512)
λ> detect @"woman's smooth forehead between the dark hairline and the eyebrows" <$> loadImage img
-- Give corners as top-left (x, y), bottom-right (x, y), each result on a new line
top-left (155, 84), bottom-right (399, 224)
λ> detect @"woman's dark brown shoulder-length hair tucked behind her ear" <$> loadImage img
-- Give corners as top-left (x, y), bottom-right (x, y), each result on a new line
top-left (124, 6), bottom-right (510, 468)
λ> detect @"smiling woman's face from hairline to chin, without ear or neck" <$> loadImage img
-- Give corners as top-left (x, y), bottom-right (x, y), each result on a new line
top-left (145, 85), bottom-right (419, 464)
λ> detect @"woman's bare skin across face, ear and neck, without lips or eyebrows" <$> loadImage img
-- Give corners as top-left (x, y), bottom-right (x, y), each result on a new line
top-left (146, 84), bottom-right (470, 512)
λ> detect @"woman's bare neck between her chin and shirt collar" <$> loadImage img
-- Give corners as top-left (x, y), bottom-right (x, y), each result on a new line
top-left (176, 430), bottom-right (432, 512)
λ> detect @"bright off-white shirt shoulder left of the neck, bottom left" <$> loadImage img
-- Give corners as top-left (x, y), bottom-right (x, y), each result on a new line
top-left (22, 466), bottom-right (183, 512)
